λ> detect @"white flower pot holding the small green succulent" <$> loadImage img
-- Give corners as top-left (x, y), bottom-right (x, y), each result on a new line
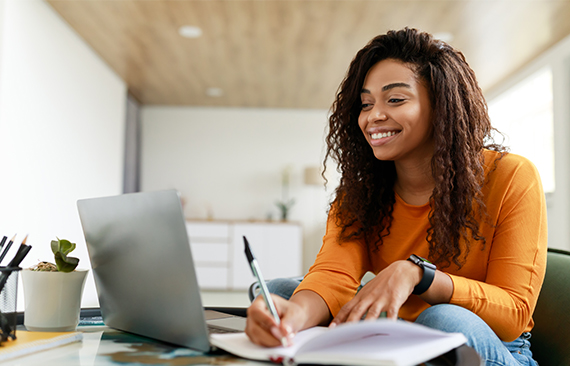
top-left (21, 269), bottom-right (88, 332)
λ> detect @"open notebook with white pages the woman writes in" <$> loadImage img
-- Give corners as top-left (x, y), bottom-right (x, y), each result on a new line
top-left (211, 319), bottom-right (467, 366)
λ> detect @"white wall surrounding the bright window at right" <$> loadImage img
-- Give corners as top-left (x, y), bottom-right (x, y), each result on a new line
top-left (486, 36), bottom-right (570, 250)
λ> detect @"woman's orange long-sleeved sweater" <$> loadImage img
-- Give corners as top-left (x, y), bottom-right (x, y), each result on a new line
top-left (296, 151), bottom-right (547, 341)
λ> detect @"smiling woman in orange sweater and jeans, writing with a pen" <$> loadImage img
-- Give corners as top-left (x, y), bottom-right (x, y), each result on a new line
top-left (246, 28), bottom-right (547, 365)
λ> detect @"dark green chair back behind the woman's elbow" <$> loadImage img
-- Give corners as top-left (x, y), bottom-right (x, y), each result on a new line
top-left (530, 249), bottom-right (570, 366)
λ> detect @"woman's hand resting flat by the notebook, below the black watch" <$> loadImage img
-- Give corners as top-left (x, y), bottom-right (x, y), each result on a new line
top-left (330, 260), bottom-right (422, 327)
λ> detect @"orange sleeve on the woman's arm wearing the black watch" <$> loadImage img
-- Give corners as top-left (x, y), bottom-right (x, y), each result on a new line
top-left (450, 154), bottom-right (547, 341)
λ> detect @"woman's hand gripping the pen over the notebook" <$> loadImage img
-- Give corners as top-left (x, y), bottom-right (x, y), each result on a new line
top-left (245, 295), bottom-right (306, 347)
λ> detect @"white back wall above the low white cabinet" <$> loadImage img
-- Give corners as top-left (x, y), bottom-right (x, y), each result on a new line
top-left (141, 106), bottom-right (334, 270)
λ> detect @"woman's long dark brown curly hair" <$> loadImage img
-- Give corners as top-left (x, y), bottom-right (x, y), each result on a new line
top-left (323, 28), bottom-right (506, 267)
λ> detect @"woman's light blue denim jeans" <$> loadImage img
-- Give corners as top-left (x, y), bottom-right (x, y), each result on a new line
top-left (267, 278), bottom-right (538, 366)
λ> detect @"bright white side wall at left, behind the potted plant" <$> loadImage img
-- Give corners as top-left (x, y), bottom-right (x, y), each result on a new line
top-left (0, 0), bottom-right (126, 310)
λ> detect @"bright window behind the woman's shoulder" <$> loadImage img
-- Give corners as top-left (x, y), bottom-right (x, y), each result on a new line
top-left (489, 67), bottom-right (555, 193)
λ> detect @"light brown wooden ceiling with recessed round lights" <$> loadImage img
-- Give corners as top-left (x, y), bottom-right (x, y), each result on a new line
top-left (47, 0), bottom-right (570, 109)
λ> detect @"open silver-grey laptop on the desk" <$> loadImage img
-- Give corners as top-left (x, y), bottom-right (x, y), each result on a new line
top-left (77, 190), bottom-right (246, 352)
